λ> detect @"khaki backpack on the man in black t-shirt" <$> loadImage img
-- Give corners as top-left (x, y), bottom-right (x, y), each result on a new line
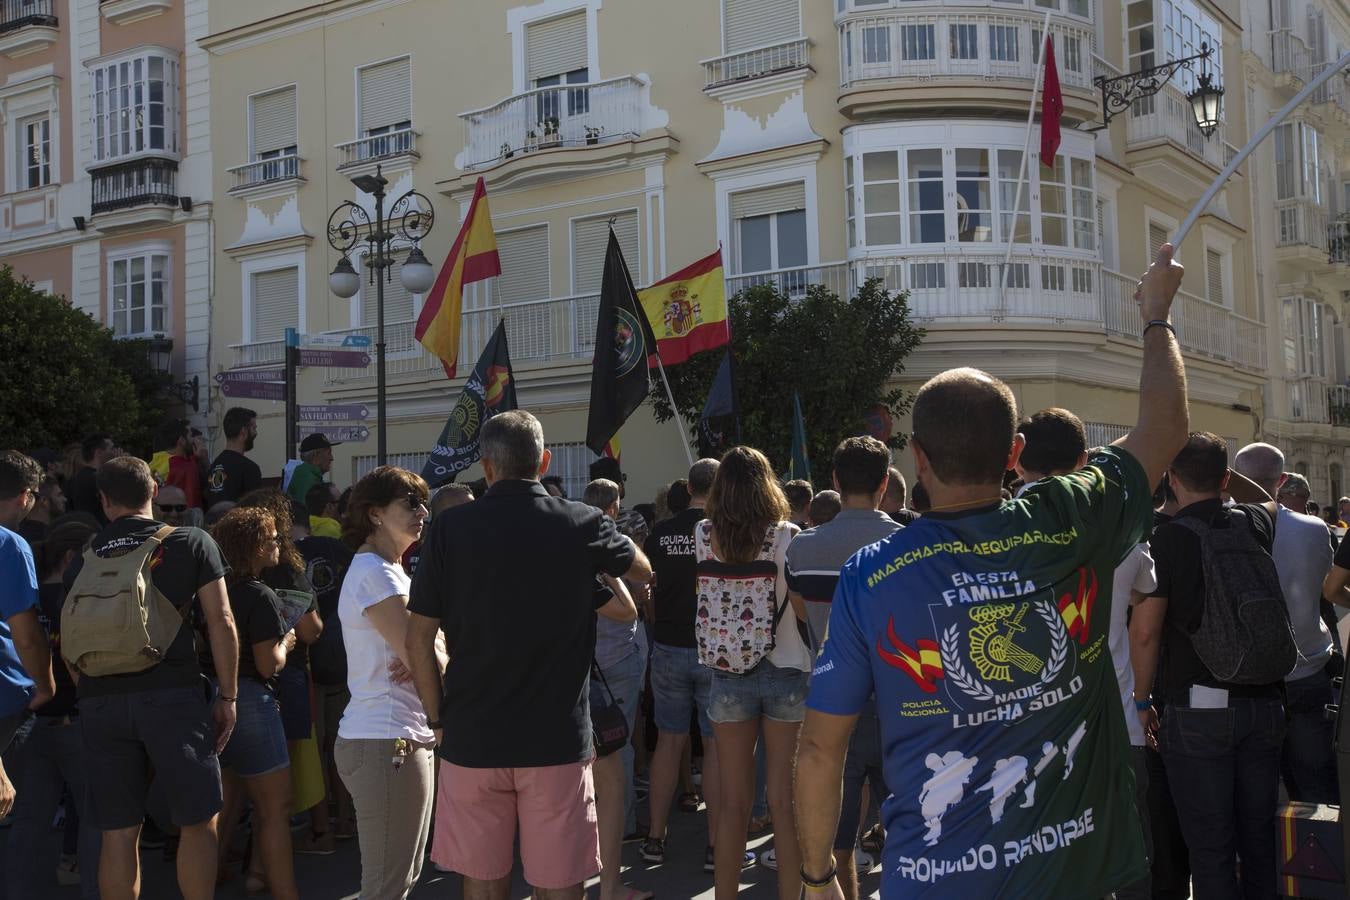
top-left (61, 525), bottom-right (182, 677)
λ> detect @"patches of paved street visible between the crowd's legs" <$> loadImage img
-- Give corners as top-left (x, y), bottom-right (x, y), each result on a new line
top-left (0, 811), bottom-right (880, 900)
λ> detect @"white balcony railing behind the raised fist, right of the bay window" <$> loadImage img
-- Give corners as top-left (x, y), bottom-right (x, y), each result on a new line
top-left (1102, 270), bottom-right (1266, 371)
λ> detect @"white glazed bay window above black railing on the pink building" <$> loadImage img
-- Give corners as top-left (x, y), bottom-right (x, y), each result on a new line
top-left (89, 51), bottom-right (178, 163)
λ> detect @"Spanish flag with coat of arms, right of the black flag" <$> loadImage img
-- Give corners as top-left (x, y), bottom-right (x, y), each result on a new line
top-left (637, 248), bottom-right (730, 367)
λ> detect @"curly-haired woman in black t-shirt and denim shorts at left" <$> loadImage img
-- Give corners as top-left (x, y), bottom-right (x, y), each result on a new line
top-left (205, 507), bottom-right (300, 900)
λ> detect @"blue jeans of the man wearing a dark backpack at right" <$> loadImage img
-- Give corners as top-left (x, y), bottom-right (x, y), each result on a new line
top-left (1158, 696), bottom-right (1284, 900)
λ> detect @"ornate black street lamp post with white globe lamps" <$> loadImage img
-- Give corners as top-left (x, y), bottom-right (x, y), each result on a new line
top-left (328, 166), bottom-right (436, 466)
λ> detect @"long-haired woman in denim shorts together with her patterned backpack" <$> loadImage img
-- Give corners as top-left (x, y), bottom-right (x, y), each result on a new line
top-left (694, 447), bottom-right (811, 900)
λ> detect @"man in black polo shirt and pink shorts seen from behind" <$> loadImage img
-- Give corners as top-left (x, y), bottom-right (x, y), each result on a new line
top-left (406, 410), bottom-right (652, 900)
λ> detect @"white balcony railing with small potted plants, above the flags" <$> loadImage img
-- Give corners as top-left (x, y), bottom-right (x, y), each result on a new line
top-left (459, 76), bottom-right (647, 169)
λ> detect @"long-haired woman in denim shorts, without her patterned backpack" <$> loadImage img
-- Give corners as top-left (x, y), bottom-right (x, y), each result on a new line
top-left (695, 447), bottom-right (811, 900)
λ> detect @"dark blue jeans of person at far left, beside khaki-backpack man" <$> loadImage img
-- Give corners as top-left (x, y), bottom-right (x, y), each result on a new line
top-left (4, 716), bottom-right (103, 900)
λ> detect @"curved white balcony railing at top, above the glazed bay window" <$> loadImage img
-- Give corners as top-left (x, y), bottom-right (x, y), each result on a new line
top-left (840, 9), bottom-right (1092, 88)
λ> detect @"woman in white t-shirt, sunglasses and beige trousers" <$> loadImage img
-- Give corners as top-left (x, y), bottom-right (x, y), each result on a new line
top-left (333, 466), bottom-right (444, 900)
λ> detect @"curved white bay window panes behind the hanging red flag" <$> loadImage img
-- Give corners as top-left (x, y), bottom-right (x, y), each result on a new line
top-left (845, 147), bottom-right (1096, 252)
